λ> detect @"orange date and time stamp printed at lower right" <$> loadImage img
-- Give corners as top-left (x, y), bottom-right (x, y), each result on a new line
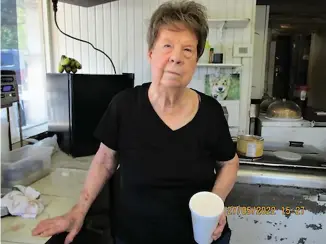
top-left (226, 206), bottom-right (305, 215)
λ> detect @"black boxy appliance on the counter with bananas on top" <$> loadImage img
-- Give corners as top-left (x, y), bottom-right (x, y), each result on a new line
top-left (46, 73), bottom-right (134, 157)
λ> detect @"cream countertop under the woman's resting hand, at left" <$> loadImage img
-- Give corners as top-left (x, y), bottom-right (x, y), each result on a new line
top-left (1, 152), bottom-right (92, 244)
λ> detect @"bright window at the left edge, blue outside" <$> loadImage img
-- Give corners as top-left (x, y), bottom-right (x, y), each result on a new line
top-left (1, 0), bottom-right (47, 142)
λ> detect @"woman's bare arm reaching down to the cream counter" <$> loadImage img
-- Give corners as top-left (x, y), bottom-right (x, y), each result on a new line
top-left (76, 143), bottom-right (117, 215)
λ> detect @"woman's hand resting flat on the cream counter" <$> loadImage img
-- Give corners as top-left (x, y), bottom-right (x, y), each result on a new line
top-left (32, 205), bottom-right (86, 244)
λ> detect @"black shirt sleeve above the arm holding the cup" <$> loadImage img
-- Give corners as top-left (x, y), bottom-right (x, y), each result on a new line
top-left (214, 103), bottom-right (236, 162)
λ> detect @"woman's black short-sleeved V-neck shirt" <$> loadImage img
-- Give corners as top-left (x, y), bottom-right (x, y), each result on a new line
top-left (95, 83), bottom-right (235, 244)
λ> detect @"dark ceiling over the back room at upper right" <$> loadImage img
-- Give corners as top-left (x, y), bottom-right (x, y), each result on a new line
top-left (257, 0), bottom-right (326, 33)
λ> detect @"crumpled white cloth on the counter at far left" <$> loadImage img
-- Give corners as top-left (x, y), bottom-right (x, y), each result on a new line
top-left (1, 185), bottom-right (44, 218)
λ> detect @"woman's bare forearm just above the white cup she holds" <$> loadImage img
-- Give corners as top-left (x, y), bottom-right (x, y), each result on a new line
top-left (212, 154), bottom-right (239, 201)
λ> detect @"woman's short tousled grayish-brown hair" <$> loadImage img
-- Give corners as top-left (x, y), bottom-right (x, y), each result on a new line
top-left (147, 1), bottom-right (209, 59)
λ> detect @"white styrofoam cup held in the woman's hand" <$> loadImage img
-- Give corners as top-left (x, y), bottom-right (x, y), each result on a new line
top-left (189, 191), bottom-right (224, 244)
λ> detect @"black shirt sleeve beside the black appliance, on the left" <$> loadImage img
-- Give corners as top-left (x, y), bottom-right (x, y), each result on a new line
top-left (94, 95), bottom-right (120, 151)
